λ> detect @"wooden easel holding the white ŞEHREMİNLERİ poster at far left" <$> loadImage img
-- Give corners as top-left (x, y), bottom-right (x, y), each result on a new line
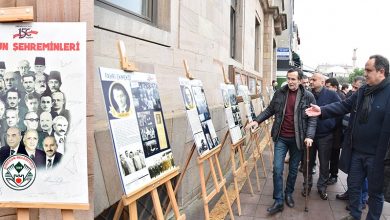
top-left (0, 6), bottom-right (86, 220)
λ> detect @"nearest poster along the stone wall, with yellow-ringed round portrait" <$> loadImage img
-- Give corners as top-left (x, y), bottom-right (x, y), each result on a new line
top-left (99, 67), bottom-right (175, 195)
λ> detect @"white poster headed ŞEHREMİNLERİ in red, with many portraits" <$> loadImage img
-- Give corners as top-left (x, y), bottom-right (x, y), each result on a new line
top-left (0, 22), bottom-right (89, 205)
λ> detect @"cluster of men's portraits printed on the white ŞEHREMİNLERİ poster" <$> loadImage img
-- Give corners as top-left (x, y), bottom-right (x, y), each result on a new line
top-left (0, 57), bottom-right (70, 169)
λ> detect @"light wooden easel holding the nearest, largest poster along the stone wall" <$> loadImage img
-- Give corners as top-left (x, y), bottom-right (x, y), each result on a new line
top-left (114, 40), bottom-right (186, 220)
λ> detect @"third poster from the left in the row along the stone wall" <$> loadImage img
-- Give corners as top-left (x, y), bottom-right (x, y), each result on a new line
top-left (221, 83), bottom-right (245, 144)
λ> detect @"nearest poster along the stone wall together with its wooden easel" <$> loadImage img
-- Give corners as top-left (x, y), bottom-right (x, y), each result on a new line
top-left (99, 41), bottom-right (185, 220)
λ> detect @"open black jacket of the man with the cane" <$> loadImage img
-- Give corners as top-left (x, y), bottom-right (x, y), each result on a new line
top-left (255, 85), bottom-right (317, 150)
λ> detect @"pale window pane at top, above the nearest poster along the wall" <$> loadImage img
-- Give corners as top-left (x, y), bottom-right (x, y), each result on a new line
top-left (98, 0), bottom-right (153, 22)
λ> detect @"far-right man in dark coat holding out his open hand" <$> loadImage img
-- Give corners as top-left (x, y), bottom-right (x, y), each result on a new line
top-left (306, 55), bottom-right (390, 219)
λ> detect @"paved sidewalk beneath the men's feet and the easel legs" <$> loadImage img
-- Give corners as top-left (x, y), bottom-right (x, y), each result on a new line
top-left (225, 155), bottom-right (390, 220)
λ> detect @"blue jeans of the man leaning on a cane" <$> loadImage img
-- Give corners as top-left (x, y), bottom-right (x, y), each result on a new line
top-left (273, 137), bottom-right (302, 204)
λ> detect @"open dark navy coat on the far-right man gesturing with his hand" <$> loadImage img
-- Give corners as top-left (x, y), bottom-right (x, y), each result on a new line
top-left (321, 85), bottom-right (390, 194)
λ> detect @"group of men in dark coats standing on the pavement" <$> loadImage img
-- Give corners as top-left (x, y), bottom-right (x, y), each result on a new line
top-left (246, 55), bottom-right (390, 219)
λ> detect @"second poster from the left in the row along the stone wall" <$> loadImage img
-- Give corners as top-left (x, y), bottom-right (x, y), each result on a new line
top-left (179, 78), bottom-right (219, 156)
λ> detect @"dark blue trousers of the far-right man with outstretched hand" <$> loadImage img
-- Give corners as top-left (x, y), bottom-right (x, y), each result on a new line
top-left (347, 151), bottom-right (384, 220)
